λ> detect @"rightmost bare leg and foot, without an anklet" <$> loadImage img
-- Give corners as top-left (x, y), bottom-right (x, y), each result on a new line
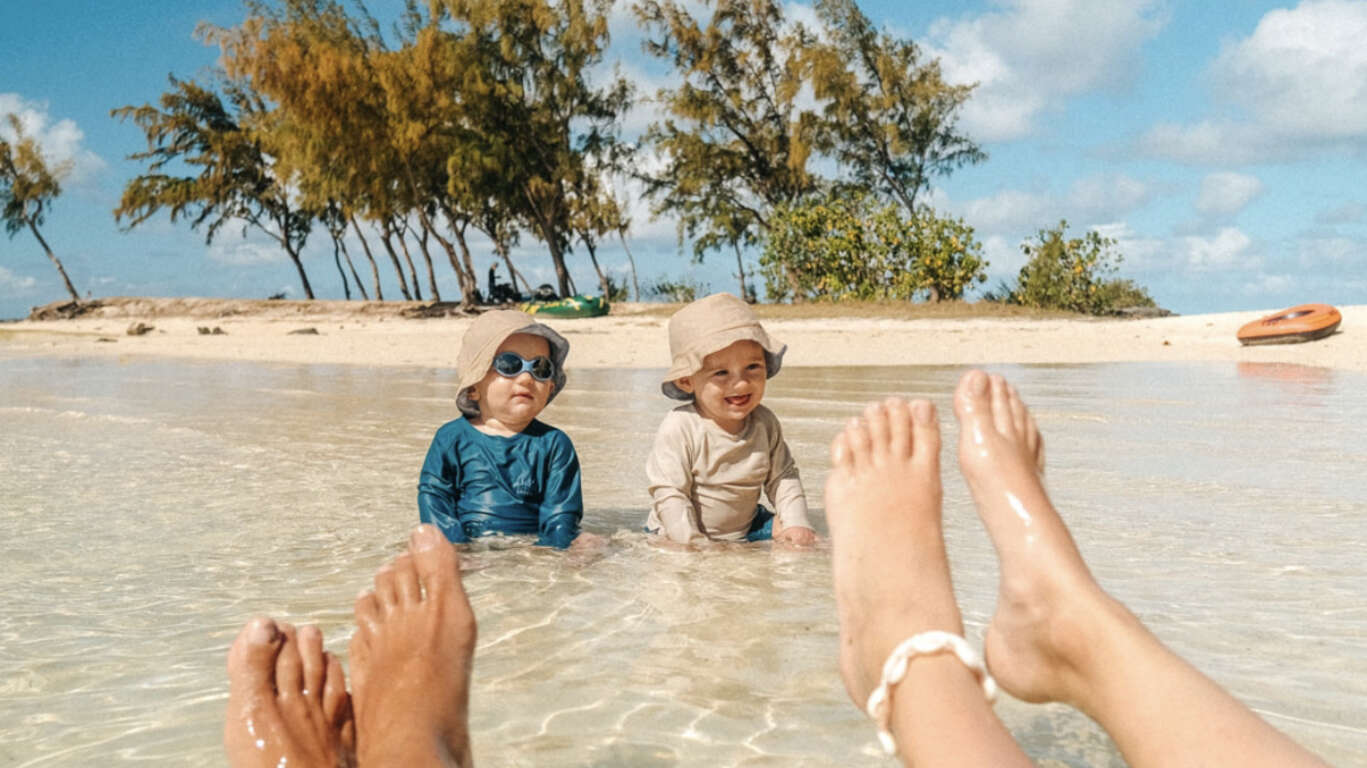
top-left (954, 370), bottom-right (1323, 768)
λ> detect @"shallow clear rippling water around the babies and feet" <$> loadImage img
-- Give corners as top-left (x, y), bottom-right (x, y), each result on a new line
top-left (0, 358), bottom-right (1367, 767)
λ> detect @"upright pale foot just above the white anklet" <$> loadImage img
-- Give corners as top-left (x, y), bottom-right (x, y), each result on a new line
top-left (826, 399), bottom-right (964, 708)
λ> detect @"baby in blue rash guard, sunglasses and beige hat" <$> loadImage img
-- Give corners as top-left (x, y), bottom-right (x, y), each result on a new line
top-left (418, 310), bottom-right (584, 549)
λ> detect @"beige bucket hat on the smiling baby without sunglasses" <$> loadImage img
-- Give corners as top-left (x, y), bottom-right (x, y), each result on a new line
top-left (660, 294), bottom-right (787, 400)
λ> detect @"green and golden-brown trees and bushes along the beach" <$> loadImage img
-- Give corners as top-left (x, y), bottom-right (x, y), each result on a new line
top-left (0, 0), bottom-right (1147, 314)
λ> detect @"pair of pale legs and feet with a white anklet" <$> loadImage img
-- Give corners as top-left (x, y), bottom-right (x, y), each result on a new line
top-left (826, 370), bottom-right (1325, 768)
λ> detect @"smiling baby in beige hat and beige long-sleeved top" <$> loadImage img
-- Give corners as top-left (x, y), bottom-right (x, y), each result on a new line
top-left (645, 294), bottom-right (816, 545)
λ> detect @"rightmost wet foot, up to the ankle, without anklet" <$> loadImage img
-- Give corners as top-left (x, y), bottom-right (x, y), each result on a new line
top-left (954, 370), bottom-right (1124, 704)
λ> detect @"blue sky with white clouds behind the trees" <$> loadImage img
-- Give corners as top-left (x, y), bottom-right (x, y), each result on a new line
top-left (0, 0), bottom-right (1367, 318)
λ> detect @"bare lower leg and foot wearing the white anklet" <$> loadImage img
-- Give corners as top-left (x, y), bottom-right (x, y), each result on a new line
top-left (826, 399), bottom-right (1029, 765)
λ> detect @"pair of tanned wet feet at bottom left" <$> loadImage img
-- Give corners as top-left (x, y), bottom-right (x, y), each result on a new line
top-left (223, 525), bottom-right (476, 768)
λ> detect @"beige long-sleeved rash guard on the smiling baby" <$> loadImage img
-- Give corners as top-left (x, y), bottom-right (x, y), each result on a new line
top-left (645, 403), bottom-right (812, 541)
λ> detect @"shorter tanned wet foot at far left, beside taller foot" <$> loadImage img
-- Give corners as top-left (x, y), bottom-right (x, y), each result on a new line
top-left (223, 618), bottom-right (354, 768)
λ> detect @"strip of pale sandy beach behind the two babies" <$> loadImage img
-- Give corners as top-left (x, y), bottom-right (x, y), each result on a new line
top-left (0, 298), bottom-right (1367, 373)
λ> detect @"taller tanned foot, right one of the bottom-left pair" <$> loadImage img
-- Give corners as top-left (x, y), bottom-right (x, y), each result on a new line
top-left (350, 525), bottom-right (476, 767)
